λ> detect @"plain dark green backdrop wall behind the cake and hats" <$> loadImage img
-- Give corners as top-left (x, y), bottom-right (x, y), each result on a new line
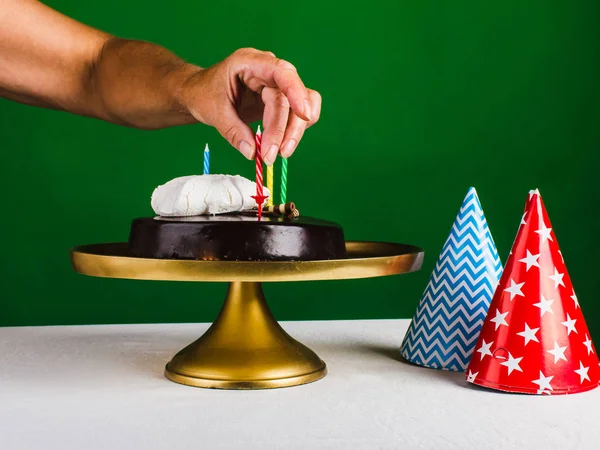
top-left (0, 0), bottom-right (600, 339)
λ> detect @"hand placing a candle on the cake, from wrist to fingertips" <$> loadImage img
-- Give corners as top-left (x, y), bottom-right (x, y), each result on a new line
top-left (181, 48), bottom-right (321, 165)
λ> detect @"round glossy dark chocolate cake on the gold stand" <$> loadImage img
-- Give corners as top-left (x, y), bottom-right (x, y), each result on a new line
top-left (129, 213), bottom-right (346, 261)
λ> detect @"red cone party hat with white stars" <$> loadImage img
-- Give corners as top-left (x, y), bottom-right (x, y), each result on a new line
top-left (467, 190), bottom-right (600, 395)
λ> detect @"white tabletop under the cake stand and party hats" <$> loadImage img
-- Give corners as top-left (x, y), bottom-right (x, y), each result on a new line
top-left (0, 320), bottom-right (600, 450)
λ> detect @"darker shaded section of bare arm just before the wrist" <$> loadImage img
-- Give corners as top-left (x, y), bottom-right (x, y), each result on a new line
top-left (86, 38), bottom-right (201, 129)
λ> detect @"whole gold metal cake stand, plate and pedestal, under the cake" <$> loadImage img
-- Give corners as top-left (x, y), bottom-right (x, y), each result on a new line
top-left (71, 242), bottom-right (423, 389)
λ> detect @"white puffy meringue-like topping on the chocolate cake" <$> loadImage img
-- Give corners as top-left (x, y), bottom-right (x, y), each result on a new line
top-left (151, 174), bottom-right (271, 217)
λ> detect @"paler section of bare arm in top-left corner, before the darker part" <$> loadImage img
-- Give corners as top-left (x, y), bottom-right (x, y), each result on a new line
top-left (0, 0), bottom-right (109, 114)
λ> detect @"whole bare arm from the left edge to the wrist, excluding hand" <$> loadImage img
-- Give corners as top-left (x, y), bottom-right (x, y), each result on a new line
top-left (0, 0), bottom-right (200, 128)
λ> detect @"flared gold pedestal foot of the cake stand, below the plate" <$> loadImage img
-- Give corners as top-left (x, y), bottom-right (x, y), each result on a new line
top-left (165, 281), bottom-right (327, 389)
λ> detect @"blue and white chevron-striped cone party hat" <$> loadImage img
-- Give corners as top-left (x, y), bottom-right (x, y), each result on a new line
top-left (400, 188), bottom-right (502, 371)
